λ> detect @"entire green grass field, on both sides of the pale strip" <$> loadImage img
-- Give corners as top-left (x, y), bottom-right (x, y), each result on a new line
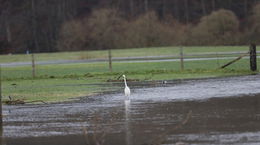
top-left (0, 46), bottom-right (260, 102)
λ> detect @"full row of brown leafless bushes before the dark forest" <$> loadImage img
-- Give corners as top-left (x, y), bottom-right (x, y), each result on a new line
top-left (58, 4), bottom-right (260, 51)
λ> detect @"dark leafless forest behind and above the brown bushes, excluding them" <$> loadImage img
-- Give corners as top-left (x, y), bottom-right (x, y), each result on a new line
top-left (0, 0), bottom-right (260, 53)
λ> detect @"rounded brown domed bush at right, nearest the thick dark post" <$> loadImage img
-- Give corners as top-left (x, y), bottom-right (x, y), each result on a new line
top-left (191, 9), bottom-right (239, 45)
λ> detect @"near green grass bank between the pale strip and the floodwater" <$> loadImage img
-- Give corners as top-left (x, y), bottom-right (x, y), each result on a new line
top-left (2, 56), bottom-right (260, 102)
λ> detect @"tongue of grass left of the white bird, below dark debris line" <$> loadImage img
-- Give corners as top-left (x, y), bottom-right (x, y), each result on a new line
top-left (3, 79), bottom-right (110, 102)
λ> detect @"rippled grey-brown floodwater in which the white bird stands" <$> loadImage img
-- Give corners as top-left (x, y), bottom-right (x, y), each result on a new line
top-left (3, 75), bottom-right (260, 145)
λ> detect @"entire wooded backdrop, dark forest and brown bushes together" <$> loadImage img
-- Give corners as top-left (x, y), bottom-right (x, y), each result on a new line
top-left (0, 0), bottom-right (260, 53)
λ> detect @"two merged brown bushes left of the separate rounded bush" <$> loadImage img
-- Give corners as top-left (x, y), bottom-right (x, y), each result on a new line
top-left (58, 9), bottom-right (194, 51)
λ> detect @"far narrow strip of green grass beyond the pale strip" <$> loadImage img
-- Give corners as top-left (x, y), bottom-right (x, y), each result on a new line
top-left (0, 46), bottom-right (248, 63)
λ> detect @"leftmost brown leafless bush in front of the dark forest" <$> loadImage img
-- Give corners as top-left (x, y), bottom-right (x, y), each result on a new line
top-left (57, 9), bottom-right (125, 51)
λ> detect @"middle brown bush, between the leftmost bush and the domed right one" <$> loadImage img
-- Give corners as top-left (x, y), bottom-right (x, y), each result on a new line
top-left (125, 11), bottom-right (187, 47)
